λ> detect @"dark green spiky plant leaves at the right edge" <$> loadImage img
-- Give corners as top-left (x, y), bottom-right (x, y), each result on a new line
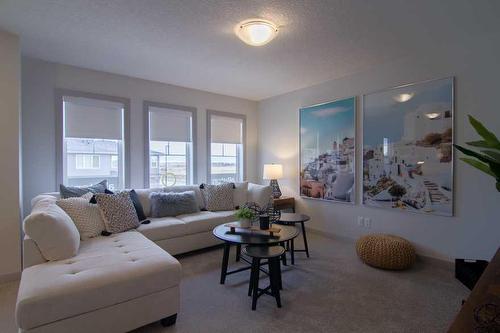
top-left (454, 115), bottom-right (500, 192)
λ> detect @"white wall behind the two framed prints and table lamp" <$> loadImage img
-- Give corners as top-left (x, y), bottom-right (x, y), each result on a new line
top-left (259, 26), bottom-right (500, 259)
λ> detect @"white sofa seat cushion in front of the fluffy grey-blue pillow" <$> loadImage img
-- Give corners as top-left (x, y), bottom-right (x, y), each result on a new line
top-left (137, 217), bottom-right (187, 241)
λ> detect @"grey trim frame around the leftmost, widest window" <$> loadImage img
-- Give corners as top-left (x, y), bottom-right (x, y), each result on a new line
top-left (55, 89), bottom-right (130, 190)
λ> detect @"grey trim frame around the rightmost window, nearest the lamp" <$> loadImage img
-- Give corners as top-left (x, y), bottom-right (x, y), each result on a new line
top-left (206, 109), bottom-right (247, 184)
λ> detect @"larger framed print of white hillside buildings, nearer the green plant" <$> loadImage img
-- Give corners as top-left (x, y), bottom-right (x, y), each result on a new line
top-left (363, 78), bottom-right (453, 216)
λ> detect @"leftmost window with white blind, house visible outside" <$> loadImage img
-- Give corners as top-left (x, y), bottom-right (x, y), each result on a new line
top-left (62, 96), bottom-right (125, 189)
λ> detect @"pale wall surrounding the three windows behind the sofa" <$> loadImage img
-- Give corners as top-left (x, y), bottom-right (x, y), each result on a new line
top-left (22, 58), bottom-right (257, 214)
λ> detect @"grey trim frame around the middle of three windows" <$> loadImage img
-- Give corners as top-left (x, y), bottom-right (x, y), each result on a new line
top-left (143, 100), bottom-right (198, 188)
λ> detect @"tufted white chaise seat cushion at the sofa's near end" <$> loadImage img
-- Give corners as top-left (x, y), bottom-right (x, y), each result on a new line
top-left (16, 231), bottom-right (181, 330)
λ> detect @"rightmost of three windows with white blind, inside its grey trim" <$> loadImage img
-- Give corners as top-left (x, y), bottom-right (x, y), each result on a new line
top-left (208, 111), bottom-right (245, 184)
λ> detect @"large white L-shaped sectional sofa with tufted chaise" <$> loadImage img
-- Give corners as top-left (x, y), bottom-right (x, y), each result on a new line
top-left (16, 183), bottom-right (271, 333)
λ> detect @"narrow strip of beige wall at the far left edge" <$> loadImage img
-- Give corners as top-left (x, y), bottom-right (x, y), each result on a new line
top-left (0, 31), bottom-right (21, 282)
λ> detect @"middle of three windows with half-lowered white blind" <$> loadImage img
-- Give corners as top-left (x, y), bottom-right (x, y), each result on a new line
top-left (145, 102), bottom-right (196, 187)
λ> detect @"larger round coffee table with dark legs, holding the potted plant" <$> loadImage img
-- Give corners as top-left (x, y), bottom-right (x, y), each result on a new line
top-left (213, 223), bottom-right (299, 284)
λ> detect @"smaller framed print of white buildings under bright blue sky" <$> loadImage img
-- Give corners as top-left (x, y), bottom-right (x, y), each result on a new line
top-left (299, 97), bottom-right (356, 203)
